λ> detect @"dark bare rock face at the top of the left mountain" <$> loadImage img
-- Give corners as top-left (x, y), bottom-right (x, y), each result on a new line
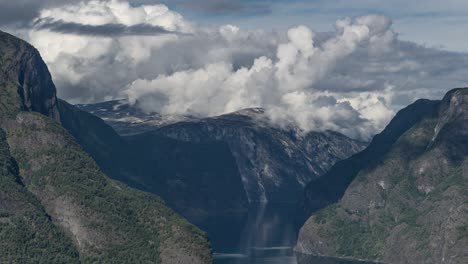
top-left (0, 31), bottom-right (59, 121)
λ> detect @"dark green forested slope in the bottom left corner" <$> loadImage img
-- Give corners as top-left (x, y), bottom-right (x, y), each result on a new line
top-left (0, 129), bottom-right (79, 263)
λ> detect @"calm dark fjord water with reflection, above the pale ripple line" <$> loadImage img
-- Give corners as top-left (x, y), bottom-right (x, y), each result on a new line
top-left (191, 203), bottom-right (297, 255)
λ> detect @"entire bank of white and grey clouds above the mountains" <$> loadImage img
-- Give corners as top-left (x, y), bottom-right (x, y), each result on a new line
top-left (7, 0), bottom-right (468, 139)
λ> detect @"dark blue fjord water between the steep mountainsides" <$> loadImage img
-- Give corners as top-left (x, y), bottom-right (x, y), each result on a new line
top-left (199, 203), bottom-right (372, 264)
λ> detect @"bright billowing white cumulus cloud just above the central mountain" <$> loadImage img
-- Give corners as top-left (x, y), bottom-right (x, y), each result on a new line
top-left (125, 16), bottom-right (393, 137)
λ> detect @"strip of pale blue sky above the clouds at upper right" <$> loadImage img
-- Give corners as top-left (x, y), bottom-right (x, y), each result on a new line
top-left (160, 0), bottom-right (468, 51)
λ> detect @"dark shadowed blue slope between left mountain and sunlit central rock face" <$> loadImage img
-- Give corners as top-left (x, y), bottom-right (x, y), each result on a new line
top-left (59, 101), bottom-right (248, 223)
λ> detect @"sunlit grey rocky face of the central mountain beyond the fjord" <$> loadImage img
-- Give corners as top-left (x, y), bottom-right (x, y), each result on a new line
top-left (154, 109), bottom-right (365, 202)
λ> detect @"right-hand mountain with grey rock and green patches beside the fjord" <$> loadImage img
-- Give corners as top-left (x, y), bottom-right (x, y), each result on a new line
top-left (296, 88), bottom-right (468, 263)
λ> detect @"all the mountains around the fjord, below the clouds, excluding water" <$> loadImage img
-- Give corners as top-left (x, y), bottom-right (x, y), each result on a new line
top-left (0, 28), bottom-right (468, 264)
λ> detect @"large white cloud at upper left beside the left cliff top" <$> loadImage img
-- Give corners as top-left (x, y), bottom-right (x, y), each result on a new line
top-left (27, 1), bottom-right (280, 102)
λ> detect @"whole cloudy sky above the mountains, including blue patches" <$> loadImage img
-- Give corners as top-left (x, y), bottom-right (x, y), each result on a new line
top-left (0, 0), bottom-right (468, 140)
